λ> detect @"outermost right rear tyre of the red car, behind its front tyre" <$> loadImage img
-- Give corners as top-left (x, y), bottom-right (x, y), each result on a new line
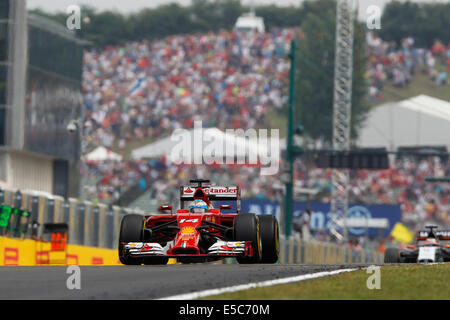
top-left (259, 215), bottom-right (280, 263)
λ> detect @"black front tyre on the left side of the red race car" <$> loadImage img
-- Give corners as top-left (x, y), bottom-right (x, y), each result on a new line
top-left (119, 214), bottom-right (144, 265)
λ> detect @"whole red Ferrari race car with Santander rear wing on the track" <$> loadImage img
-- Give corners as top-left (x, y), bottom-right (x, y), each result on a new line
top-left (118, 180), bottom-right (279, 265)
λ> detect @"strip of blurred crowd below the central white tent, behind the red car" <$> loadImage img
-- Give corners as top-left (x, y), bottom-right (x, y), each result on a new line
top-left (84, 157), bottom-right (280, 203)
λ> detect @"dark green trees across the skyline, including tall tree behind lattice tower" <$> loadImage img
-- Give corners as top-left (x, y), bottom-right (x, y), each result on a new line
top-left (32, 0), bottom-right (450, 144)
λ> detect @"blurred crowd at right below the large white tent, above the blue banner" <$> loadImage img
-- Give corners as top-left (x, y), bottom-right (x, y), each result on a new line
top-left (296, 157), bottom-right (450, 230)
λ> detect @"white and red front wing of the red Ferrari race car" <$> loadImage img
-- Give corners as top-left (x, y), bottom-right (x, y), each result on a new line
top-left (122, 240), bottom-right (253, 259)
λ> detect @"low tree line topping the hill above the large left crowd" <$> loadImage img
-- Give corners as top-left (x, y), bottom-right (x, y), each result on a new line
top-left (30, 0), bottom-right (304, 47)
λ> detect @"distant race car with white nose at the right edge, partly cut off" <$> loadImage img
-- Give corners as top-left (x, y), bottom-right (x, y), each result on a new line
top-left (384, 226), bottom-right (450, 263)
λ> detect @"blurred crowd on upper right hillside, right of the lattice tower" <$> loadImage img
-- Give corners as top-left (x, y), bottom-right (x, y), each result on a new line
top-left (366, 32), bottom-right (450, 102)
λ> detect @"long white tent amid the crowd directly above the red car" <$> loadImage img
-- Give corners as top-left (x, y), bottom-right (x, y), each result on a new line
top-left (131, 128), bottom-right (279, 162)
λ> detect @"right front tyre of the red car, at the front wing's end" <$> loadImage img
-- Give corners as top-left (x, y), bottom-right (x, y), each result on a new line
top-left (233, 213), bottom-right (261, 264)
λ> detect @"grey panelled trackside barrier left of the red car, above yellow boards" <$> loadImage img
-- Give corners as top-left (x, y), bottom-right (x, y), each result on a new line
top-left (0, 188), bottom-right (149, 252)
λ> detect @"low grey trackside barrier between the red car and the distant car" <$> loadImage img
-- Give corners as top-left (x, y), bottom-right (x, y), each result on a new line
top-left (279, 236), bottom-right (384, 264)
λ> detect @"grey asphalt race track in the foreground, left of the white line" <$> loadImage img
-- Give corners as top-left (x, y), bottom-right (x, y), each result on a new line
top-left (0, 264), bottom-right (370, 300)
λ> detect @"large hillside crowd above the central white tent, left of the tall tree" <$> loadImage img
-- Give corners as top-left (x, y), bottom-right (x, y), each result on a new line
top-left (83, 29), bottom-right (294, 149)
